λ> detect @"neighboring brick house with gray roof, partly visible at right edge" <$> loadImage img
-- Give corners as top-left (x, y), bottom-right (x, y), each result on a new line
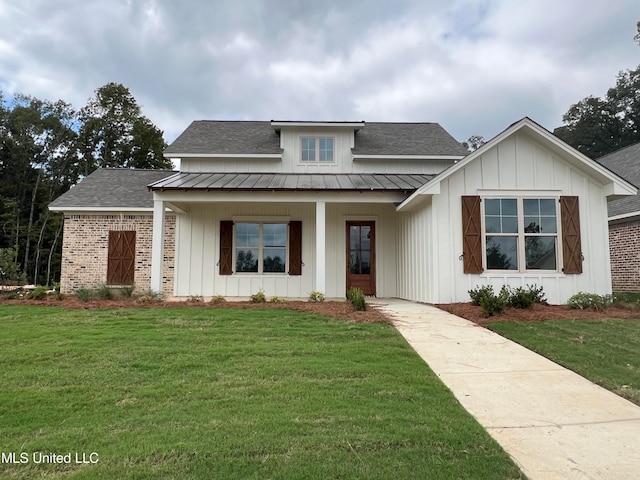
top-left (598, 143), bottom-right (640, 292)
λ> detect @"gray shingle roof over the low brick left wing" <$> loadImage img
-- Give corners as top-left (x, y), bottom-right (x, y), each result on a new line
top-left (49, 168), bottom-right (176, 211)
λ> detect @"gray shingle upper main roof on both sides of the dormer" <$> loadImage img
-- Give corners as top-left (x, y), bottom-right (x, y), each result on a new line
top-left (164, 120), bottom-right (468, 158)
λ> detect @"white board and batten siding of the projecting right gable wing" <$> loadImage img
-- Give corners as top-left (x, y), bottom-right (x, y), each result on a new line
top-left (398, 132), bottom-right (611, 303)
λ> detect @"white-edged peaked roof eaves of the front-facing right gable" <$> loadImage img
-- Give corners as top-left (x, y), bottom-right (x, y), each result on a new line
top-left (396, 117), bottom-right (638, 211)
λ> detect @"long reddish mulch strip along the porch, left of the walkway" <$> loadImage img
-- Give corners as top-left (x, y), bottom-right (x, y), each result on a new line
top-left (0, 295), bottom-right (391, 323)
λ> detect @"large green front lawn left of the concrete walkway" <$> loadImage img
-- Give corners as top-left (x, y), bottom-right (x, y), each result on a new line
top-left (0, 305), bottom-right (523, 479)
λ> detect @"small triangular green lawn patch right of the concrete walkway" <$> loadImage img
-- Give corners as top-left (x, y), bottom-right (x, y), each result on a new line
top-left (486, 319), bottom-right (640, 405)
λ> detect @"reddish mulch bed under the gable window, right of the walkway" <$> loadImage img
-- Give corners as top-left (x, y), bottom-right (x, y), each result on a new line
top-left (436, 303), bottom-right (640, 325)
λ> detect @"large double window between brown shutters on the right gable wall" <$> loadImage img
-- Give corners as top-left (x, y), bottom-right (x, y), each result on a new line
top-left (484, 198), bottom-right (558, 271)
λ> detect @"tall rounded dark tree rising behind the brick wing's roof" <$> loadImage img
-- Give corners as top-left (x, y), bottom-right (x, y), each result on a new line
top-left (78, 83), bottom-right (171, 175)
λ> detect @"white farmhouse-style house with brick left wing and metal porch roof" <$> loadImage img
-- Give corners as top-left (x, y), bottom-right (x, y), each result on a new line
top-left (51, 118), bottom-right (637, 303)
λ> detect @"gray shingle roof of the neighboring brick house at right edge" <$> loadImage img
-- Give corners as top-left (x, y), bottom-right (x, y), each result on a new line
top-left (596, 142), bottom-right (640, 219)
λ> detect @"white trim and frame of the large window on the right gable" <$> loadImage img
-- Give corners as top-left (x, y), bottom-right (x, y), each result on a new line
top-left (480, 196), bottom-right (564, 276)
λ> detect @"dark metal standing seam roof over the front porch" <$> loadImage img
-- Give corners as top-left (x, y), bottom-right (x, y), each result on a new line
top-left (149, 172), bottom-right (434, 192)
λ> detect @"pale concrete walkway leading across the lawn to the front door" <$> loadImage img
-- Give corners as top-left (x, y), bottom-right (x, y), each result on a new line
top-left (371, 299), bottom-right (640, 480)
